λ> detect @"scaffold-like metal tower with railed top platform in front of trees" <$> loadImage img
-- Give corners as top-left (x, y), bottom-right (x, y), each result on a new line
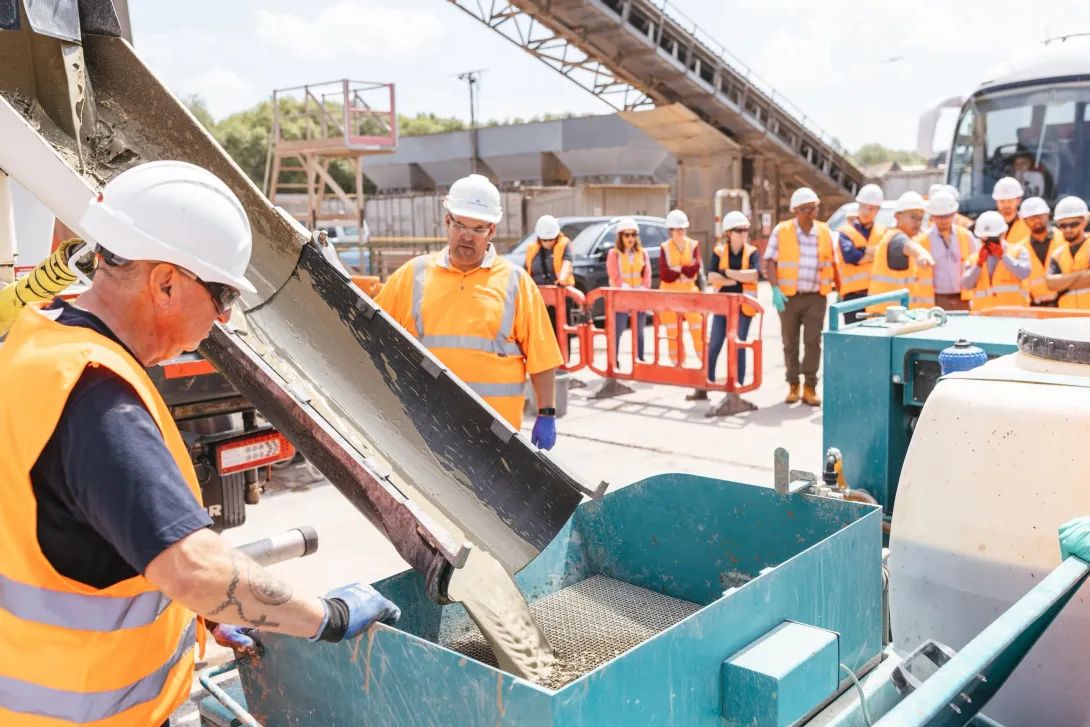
top-left (264, 80), bottom-right (398, 230)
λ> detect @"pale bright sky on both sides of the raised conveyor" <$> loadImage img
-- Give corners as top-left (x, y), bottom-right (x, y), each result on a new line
top-left (129, 0), bottom-right (1090, 149)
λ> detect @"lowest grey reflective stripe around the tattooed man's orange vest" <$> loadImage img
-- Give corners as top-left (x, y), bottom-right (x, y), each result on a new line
top-left (0, 619), bottom-right (196, 725)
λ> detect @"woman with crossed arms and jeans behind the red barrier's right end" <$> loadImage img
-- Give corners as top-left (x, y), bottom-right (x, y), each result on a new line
top-left (707, 211), bottom-right (761, 385)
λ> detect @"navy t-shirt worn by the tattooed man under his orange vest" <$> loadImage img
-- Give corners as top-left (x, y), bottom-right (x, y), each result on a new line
top-left (31, 299), bottom-right (211, 589)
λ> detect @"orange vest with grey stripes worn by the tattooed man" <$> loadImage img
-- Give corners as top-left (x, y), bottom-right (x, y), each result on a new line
top-left (0, 305), bottom-right (205, 727)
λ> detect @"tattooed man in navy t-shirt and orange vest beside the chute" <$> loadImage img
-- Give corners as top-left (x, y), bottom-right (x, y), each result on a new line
top-left (0, 161), bottom-right (400, 727)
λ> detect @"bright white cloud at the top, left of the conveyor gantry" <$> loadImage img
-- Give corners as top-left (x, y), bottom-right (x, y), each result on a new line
top-left (257, 0), bottom-right (444, 60)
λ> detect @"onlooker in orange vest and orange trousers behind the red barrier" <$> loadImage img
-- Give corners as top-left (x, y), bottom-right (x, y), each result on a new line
top-left (658, 209), bottom-right (707, 401)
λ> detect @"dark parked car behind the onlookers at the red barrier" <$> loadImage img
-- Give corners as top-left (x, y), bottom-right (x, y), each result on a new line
top-left (504, 215), bottom-right (670, 318)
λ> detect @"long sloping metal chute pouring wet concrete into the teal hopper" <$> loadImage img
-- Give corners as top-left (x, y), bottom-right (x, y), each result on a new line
top-left (0, 0), bottom-right (593, 599)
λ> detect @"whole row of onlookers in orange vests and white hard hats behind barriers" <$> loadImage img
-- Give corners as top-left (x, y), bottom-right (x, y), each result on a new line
top-left (526, 177), bottom-right (1090, 407)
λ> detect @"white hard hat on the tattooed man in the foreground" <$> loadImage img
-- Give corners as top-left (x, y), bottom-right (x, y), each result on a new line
top-left (80, 161), bottom-right (256, 293)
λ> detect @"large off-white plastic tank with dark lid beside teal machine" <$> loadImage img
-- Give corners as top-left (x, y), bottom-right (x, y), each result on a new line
top-left (889, 318), bottom-right (1090, 727)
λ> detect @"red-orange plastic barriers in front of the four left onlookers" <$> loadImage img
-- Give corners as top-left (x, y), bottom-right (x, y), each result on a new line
top-left (541, 286), bottom-right (764, 393)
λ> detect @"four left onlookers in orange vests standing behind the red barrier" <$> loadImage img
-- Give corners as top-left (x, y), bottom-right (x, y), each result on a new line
top-left (525, 209), bottom-right (760, 401)
